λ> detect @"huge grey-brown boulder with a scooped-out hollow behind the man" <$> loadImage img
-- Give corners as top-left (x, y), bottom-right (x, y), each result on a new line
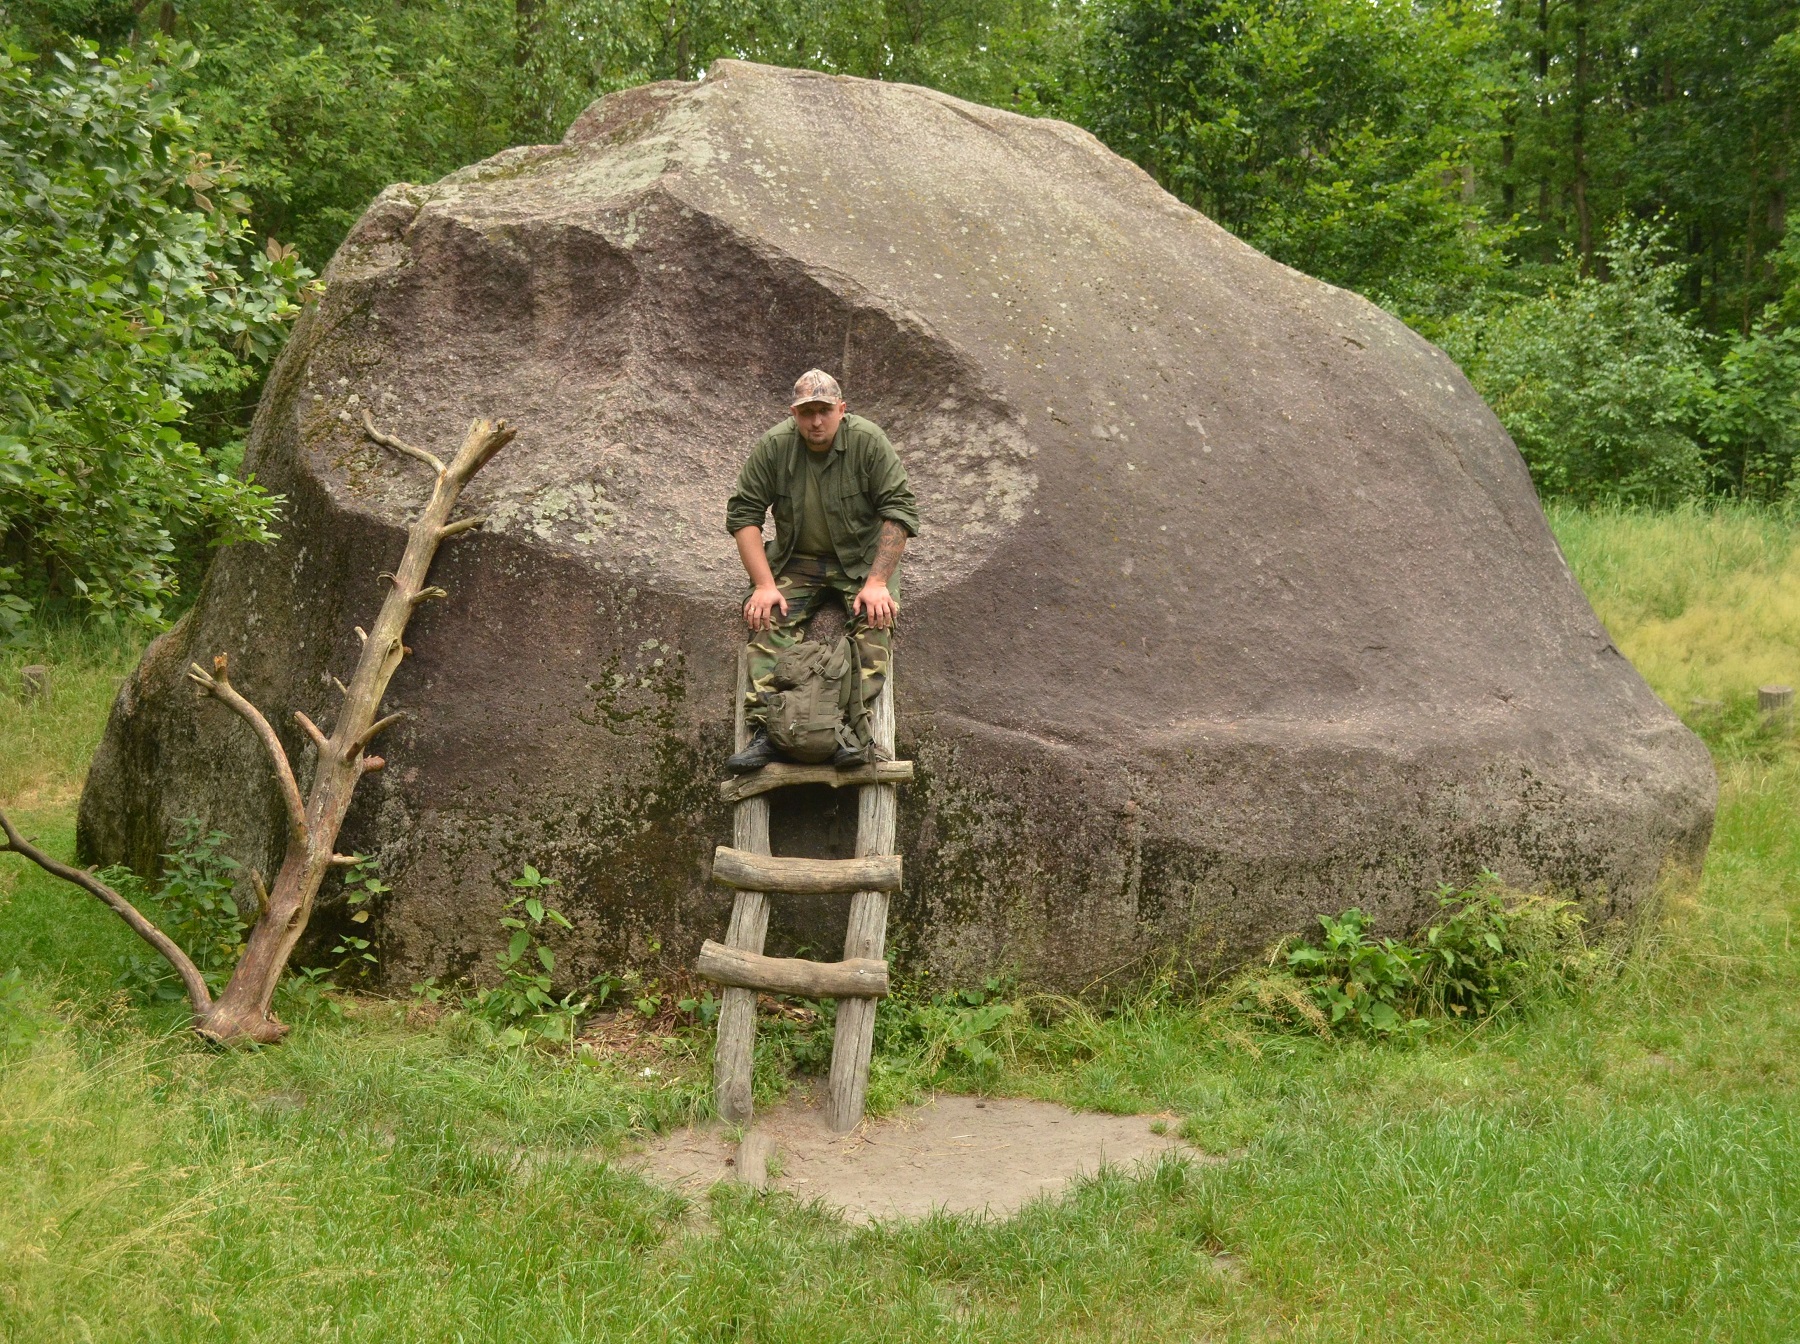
top-left (81, 61), bottom-right (1715, 988)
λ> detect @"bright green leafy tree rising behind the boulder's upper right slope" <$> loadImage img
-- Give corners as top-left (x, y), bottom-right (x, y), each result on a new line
top-left (1073, 0), bottom-right (1501, 317)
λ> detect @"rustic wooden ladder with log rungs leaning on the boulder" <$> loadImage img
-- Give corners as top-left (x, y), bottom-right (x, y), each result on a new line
top-left (695, 650), bottom-right (913, 1133)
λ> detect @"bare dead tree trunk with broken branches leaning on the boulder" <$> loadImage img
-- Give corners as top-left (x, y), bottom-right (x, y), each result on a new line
top-left (0, 414), bottom-right (513, 1044)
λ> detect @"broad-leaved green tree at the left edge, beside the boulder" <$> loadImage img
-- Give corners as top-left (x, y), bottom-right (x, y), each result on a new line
top-left (0, 47), bottom-right (306, 630)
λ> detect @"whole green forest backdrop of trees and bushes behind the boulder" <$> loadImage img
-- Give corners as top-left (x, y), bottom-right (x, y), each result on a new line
top-left (0, 0), bottom-right (1800, 641)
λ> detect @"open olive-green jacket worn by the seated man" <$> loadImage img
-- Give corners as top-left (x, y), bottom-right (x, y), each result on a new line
top-left (725, 416), bottom-right (918, 579)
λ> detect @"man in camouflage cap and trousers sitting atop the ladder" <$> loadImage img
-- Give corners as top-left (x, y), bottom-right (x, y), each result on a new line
top-left (725, 369), bottom-right (918, 774)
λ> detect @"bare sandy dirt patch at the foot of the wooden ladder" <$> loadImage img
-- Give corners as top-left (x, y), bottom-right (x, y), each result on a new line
top-left (637, 1096), bottom-right (1224, 1222)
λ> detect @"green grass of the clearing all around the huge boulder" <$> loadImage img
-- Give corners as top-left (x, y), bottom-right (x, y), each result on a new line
top-left (0, 513), bottom-right (1800, 1344)
